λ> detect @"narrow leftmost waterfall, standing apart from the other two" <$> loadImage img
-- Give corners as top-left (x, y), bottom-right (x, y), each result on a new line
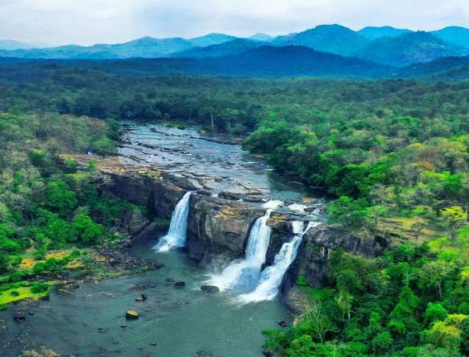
top-left (154, 192), bottom-right (192, 252)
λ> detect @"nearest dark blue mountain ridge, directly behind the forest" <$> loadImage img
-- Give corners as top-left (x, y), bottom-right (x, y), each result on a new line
top-left (0, 40), bottom-right (469, 81)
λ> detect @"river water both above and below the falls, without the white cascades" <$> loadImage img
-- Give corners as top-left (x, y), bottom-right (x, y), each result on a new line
top-left (0, 125), bottom-right (319, 357)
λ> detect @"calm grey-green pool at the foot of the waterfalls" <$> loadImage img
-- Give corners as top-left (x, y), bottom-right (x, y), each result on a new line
top-left (0, 237), bottom-right (290, 357)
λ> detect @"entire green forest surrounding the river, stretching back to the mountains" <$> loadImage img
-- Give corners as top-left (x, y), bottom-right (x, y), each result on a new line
top-left (0, 64), bottom-right (469, 357)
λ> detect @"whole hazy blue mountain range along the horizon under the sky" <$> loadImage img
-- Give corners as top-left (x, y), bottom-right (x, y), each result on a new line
top-left (0, 25), bottom-right (469, 77)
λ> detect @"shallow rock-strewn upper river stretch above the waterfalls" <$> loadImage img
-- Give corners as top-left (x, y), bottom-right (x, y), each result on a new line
top-left (119, 121), bottom-right (323, 202)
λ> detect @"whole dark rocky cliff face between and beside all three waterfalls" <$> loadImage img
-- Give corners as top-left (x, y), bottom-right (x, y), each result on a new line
top-left (102, 174), bottom-right (388, 309)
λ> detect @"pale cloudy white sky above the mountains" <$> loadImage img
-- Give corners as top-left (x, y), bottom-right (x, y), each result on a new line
top-left (0, 0), bottom-right (469, 45)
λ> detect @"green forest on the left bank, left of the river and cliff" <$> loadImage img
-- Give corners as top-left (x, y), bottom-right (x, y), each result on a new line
top-left (0, 110), bottom-right (133, 310)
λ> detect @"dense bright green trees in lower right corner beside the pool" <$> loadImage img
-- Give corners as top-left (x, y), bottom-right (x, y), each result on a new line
top-left (265, 245), bottom-right (469, 357)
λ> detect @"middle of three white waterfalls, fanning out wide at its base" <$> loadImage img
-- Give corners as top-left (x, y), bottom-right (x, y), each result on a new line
top-left (210, 209), bottom-right (272, 291)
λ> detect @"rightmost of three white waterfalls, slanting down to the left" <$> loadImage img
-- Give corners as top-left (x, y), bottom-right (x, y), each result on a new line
top-left (240, 222), bottom-right (320, 303)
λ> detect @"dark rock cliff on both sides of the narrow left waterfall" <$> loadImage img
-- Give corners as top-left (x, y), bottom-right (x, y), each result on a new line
top-left (102, 173), bottom-right (264, 265)
